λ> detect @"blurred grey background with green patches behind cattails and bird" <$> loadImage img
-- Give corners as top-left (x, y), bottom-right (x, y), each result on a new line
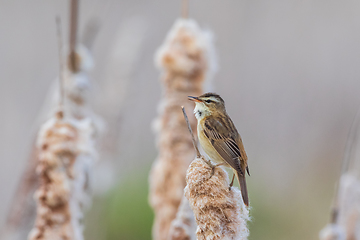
top-left (0, 0), bottom-right (360, 240)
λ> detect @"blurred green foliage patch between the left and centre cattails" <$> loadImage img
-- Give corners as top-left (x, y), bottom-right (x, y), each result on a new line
top-left (85, 167), bottom-right (154, 240)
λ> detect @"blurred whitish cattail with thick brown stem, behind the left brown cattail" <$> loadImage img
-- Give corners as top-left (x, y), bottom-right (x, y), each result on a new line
top-left (60, 7), bottom-right (104, 212)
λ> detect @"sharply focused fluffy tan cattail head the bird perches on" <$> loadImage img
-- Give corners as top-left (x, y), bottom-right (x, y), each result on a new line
top-left (185, 157), bottom-right (249, 240)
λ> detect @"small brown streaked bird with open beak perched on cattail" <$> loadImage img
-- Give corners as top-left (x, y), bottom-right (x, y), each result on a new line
top-left (189, 93), bottom-right (250, 206)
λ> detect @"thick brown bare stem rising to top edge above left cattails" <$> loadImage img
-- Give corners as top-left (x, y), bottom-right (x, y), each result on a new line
top-left (69, 0), bottom-right (79, 72)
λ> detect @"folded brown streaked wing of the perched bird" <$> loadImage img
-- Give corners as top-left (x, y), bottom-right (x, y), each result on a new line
top-left (204, 118), bottom-right (245, 174)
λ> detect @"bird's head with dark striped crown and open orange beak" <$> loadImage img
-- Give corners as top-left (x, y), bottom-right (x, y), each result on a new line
top-left (188, 93), bottom-right (225, 119)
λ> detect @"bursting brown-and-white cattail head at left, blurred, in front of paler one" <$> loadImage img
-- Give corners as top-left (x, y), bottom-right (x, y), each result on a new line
top-left (28, 114), bottom-right (96, 240)
